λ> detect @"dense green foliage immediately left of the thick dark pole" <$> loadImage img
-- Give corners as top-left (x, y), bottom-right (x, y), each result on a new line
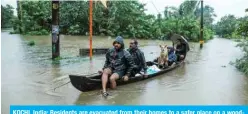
top-left (13, 1), bottom-right (51, 35)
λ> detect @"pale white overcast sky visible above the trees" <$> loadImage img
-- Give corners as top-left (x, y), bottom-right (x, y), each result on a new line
top-left (1, 0), bottom-right (248, 22)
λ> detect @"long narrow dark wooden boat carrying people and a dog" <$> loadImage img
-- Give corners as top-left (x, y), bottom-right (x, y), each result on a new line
top-left (69, 61), bottom-right (183, 92)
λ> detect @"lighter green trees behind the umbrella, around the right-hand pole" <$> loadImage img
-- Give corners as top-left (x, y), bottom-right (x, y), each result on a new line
top-left (162, 1), bottom-right (216, 41)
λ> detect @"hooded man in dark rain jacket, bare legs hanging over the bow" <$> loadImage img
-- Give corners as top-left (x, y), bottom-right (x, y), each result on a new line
top-left (102, 36), bottom-right (134, 97)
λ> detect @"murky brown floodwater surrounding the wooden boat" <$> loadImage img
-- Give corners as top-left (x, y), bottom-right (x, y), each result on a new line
top-left (1, 32), bottom-right (248, 114)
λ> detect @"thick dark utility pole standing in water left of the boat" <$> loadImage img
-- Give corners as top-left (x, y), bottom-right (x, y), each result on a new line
top-left (52, 0), bottom-right (60, 59)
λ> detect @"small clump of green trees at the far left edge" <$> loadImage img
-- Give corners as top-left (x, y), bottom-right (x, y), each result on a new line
top-left (1, 5), bottom-right (14, 28)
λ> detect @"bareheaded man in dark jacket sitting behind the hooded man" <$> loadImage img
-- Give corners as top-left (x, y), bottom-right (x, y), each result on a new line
top-left (127, 39), bottom-right (147, 78)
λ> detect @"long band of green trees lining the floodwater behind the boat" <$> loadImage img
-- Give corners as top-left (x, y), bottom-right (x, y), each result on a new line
top-left (13, 1), bottom-right (214, 41)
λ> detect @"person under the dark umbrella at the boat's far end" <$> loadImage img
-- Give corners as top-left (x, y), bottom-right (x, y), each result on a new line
top-left (176, 39), bottom-right (187, 61)
